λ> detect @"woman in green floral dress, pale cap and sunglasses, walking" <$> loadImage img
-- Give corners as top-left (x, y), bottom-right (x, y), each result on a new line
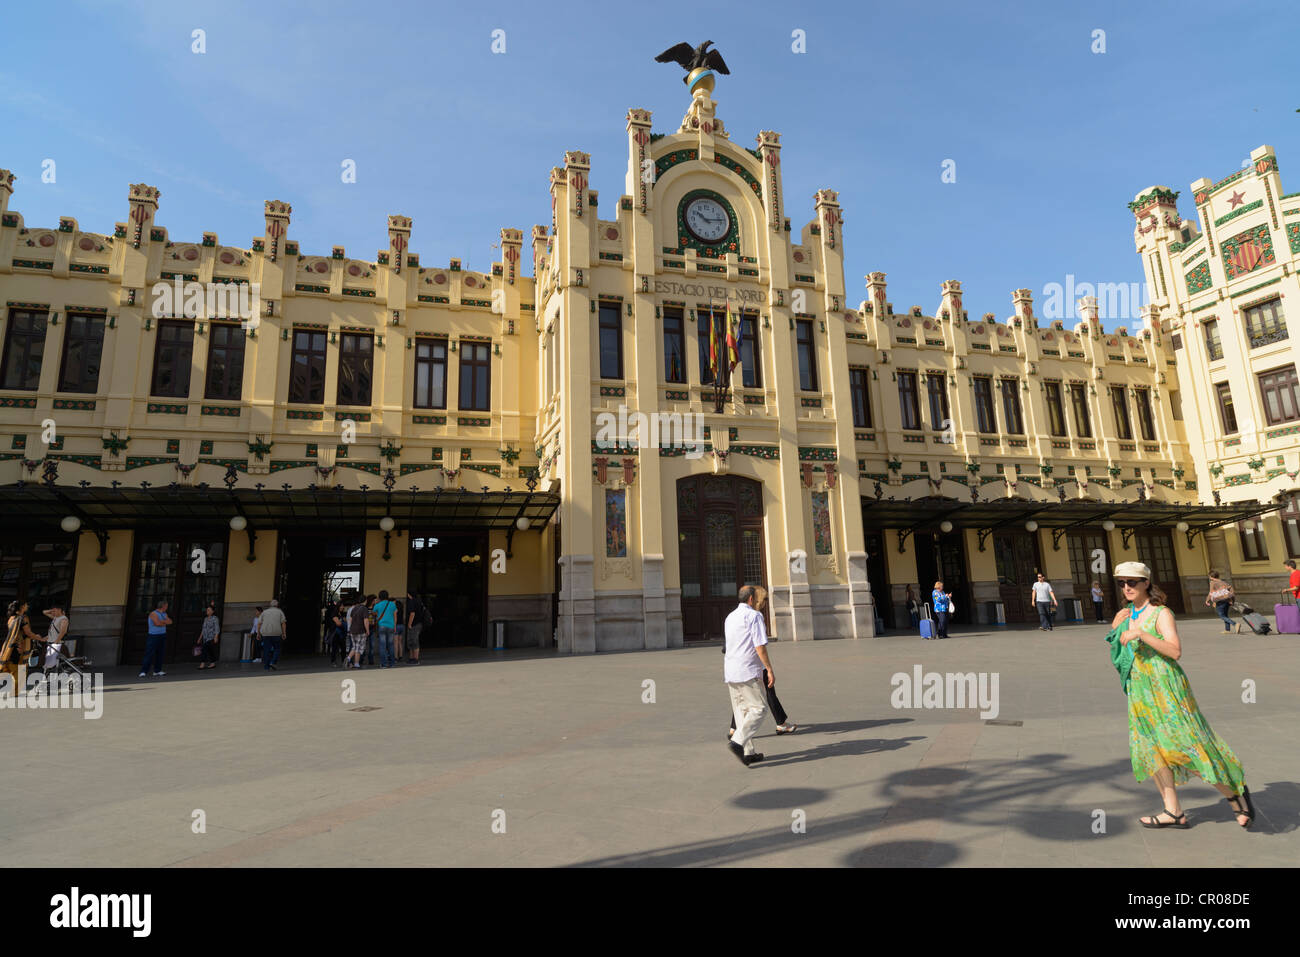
top-left (1112, 562), bottom-right (1255, 828)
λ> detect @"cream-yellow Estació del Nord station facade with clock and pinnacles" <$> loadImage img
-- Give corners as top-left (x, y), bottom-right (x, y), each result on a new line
top-left (0, 87), bottom-right (1300, 662)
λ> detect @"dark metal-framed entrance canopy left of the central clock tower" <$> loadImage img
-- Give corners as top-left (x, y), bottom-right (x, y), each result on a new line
top-left (0, 482), bottom-right (560, 533)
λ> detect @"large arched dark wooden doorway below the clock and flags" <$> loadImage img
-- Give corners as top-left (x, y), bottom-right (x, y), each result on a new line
top-left (677, 475), bottom-right (767, 641)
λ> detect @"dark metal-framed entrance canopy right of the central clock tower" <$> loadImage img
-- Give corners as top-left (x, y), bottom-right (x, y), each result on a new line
top-left (862, 497), bottom-right (1286, 551)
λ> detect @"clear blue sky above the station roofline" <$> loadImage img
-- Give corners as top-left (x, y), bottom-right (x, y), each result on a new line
top-left (0, 0), bottom-right (1300, 327)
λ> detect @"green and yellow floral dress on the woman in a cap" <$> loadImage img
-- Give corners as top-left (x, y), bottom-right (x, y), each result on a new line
top-left (1128, 603), bottom-right (1245, 793)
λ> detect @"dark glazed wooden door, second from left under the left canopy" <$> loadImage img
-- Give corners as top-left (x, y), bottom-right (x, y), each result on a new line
top-left (122, 533), bottom-right (228, 664)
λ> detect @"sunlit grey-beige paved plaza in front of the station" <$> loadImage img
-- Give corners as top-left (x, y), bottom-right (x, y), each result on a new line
top-left (0, 618), bottom-right (1300, 867)
